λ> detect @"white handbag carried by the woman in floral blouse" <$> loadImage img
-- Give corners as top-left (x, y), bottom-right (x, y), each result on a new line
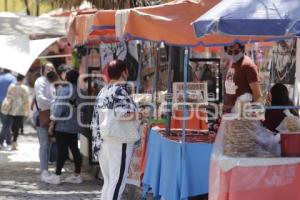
top-left (99, 109), bottom-right (141, 143)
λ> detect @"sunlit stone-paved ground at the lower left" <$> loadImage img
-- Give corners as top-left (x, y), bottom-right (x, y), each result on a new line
top-left (0, 126), bottom-right (140, 200)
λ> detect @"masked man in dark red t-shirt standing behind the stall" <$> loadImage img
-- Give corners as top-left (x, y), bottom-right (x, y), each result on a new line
top-left (224, 43), bottom-right (261, 113)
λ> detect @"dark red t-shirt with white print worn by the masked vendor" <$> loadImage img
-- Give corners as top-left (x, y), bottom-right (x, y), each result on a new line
top-left (224, 56), bottom-right (259, 112)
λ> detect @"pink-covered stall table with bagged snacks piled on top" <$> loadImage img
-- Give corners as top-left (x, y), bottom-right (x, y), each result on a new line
top-left (209, 116), bottom-right (300, 200)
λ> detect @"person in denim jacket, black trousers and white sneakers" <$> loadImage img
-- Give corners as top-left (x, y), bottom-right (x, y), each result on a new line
top-left (46, 70), bottom-right (82, 184)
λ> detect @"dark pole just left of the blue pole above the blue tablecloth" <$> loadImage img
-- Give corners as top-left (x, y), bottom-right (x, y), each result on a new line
top-left (166, 46), bottom-right (173, 135)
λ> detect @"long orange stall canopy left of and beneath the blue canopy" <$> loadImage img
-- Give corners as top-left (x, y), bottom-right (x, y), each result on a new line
top-left (68, 0), bottom-right (282, 47)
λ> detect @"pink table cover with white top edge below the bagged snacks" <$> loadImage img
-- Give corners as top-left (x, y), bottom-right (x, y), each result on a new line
top-left (209, 156), bottom-right (300, 200)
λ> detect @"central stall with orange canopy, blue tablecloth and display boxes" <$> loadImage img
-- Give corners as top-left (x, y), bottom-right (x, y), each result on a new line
top-left (116, 1), bottom-right (217, 199)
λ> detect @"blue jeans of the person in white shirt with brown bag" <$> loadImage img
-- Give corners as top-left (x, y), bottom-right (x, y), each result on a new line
top-left (37, 127), bottom-right (49, 172)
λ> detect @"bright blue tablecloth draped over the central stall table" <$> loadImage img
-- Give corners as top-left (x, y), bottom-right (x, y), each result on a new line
top-left (143, 130), bottom-right (212, 200)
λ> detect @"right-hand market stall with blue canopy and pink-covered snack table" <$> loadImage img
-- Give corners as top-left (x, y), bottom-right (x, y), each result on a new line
top-left (193, 0), bottom-right (300, 200)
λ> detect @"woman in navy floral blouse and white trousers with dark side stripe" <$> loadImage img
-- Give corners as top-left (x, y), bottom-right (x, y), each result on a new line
top-left (92, 60), bottom-right (139, 200)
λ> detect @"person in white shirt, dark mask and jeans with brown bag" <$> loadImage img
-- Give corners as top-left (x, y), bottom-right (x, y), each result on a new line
top-left (34, 63), bottom-right (58, 182)
